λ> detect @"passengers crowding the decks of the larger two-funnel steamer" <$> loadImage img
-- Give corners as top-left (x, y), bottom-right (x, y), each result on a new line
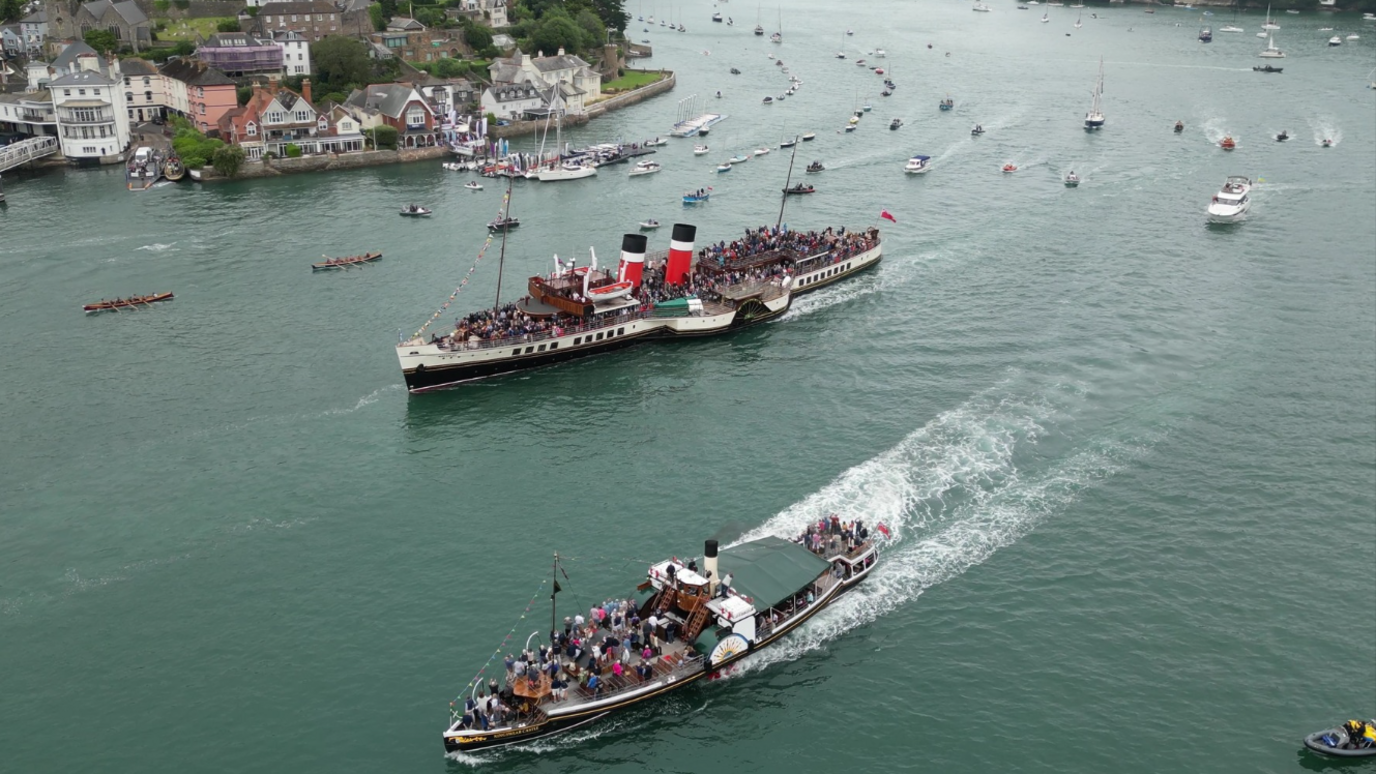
top-left (431, 226), bottom-right (878, 348)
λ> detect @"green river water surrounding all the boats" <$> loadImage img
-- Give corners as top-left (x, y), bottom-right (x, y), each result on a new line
top-left (0, 0), bottom-right (1376, 773)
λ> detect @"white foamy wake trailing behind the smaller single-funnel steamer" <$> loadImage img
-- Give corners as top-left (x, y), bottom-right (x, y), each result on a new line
top-left (732, 377), bottom-right (1143, 676)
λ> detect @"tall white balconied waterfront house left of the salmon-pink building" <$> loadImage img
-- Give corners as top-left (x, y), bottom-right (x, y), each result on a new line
top-left (48, 56), bottom-right (129, 167)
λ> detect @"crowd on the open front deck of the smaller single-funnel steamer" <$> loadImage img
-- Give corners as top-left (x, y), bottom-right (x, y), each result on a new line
top-left (458, 599), bottom-right (699, 731)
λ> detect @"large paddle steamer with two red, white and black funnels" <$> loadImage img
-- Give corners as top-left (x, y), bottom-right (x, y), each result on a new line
top-left (396, 223), bottom-right (883, 393)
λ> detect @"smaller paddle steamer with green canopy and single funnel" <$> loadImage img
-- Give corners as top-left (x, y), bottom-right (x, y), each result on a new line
top-left (443, 533), bottom-right (878, 752)
